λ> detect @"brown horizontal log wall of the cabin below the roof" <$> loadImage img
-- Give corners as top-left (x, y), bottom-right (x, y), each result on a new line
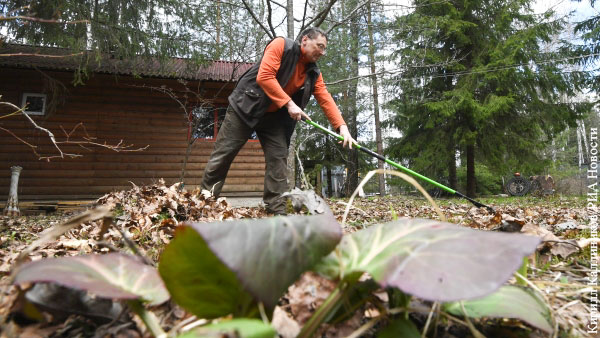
top-left (0, 69), bottom-right (265, 200)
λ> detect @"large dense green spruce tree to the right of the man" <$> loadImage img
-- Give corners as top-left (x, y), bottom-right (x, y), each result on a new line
top-left (392, 0), bottom-right (586, 196)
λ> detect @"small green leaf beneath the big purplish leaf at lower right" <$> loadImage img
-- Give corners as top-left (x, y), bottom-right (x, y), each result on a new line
top-left (444, 285), bottom-right (552, 332)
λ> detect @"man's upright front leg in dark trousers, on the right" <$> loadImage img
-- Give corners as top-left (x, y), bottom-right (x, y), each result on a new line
top-left (256, 112), bottom-right (288, 215)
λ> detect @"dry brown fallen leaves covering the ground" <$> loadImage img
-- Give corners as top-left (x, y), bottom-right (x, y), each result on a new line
top-left (0, 191), bottom-right (591, 335)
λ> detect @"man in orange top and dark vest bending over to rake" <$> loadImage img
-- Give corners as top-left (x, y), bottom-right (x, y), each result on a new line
top-left (202, 27), bottom-right (356, 215)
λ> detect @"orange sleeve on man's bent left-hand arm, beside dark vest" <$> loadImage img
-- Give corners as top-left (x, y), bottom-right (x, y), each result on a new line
top-left (256, 38), bottom-right (291, 108)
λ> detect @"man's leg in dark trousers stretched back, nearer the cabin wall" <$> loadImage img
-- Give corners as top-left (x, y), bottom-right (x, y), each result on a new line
top-left (202, 107), bottom-right (252, 197)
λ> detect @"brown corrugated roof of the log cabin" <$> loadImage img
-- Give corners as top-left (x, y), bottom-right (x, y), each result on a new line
top-left (0, 44), bottom-right (253, 81)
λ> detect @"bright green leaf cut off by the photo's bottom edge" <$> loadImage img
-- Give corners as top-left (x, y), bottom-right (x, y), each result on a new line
top-left (178, 318), bottom-right (277, 338)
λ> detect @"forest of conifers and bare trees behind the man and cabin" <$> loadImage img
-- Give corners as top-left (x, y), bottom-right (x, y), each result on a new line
top-left (0, 0), bottom-right (600, 196)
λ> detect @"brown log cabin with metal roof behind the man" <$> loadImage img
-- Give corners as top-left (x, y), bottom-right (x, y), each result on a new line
top-left (0, 44), bottom-right (265, 201)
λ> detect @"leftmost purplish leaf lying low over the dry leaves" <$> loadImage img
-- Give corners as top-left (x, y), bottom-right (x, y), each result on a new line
top-left (15, 253), bottom-right (169, 305)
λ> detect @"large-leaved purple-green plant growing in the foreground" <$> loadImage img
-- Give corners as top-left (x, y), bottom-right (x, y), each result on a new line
top-left (10, 191), bottom-right (552, 337)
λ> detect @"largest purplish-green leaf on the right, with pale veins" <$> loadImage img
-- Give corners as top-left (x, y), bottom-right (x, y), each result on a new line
top-left (316, 219), bottom-right (540, 301)
